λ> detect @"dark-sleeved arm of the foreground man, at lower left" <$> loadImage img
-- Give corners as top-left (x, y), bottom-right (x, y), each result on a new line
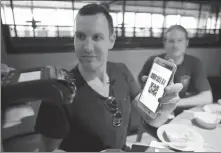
top-left (35, 102), bottom-right (70, 152)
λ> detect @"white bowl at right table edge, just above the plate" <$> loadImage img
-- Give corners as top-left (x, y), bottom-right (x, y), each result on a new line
top-left (194, 112), bottom-right (221, 129)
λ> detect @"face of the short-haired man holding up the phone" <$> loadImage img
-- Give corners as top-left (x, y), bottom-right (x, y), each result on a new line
top-left (74, 13), bottom-right (115, 71)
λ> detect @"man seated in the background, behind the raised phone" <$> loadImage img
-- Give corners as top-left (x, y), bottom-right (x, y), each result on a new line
top-left (138, 25), bottom-right (213, 114)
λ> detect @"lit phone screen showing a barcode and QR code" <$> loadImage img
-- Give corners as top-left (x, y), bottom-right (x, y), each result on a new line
top-left (140, 63), bottom-right (172, 113)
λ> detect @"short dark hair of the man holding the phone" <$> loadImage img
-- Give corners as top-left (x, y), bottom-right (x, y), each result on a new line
top-left (77, 3), bottom-right (114, 34)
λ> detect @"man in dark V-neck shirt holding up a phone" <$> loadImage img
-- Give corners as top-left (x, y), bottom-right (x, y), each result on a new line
top-left (35, 4), bottom-right (182, 152)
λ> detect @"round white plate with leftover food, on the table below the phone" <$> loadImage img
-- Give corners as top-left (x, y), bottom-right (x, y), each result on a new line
top-left (157, 124), bottom-right (204, 151)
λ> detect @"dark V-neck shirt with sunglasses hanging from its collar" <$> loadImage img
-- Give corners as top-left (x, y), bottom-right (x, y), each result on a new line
top-left (35, 62), bottom-right (140, 152)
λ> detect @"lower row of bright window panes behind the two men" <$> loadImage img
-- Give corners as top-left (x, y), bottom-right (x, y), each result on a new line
top-left (5, 25), bottom-right (220, 38)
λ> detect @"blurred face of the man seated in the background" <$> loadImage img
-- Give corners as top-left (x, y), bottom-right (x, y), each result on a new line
top-left (164, 29), bottom-right (189, 57)
